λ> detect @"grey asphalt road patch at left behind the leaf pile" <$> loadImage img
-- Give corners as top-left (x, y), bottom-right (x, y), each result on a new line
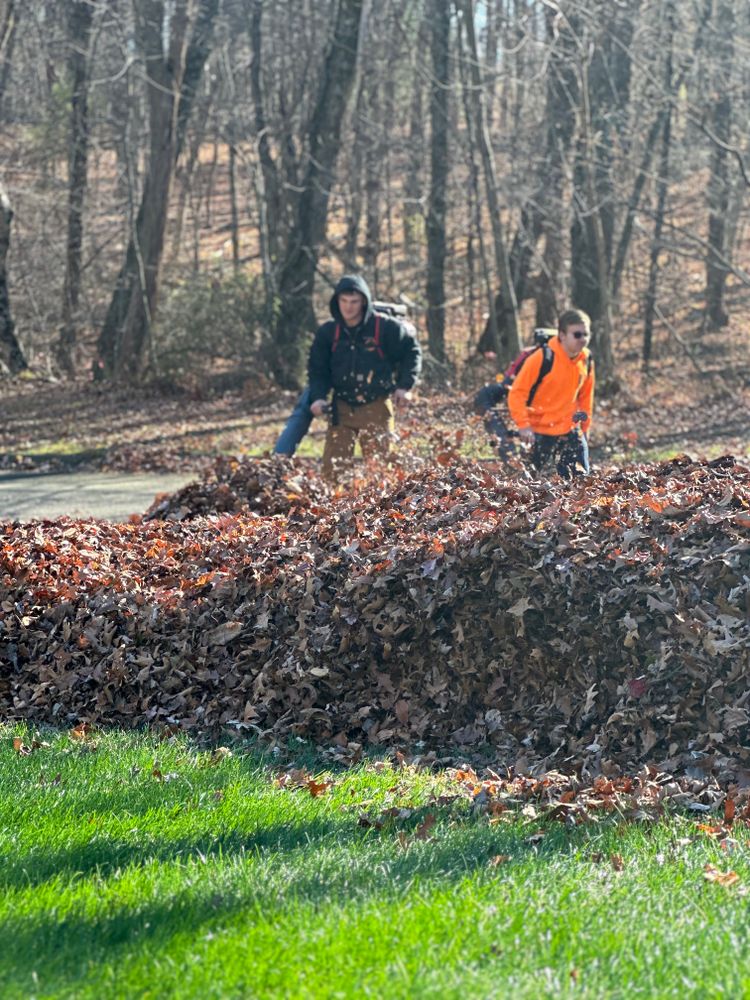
top-left (0, 472), bottom-right (195, 522)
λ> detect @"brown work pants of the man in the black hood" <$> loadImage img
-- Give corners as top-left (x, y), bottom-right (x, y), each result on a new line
top-left (323, 398), bottom-right (395, 479)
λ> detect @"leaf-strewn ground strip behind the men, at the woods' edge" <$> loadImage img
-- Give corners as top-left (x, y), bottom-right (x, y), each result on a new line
top-left (0, 310), bottom-right (750, 473)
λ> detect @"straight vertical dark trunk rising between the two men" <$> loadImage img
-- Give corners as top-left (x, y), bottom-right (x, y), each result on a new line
top-left (426, 0), bottom-right (451, 361)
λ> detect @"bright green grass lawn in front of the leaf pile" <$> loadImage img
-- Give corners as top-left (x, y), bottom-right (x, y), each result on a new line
top-left (0, 726), bottom-right (750, 1000)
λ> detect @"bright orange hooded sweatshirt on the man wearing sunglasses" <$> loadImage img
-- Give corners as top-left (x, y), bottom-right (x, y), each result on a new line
top-left (508, 337), bottom-right (594, 435)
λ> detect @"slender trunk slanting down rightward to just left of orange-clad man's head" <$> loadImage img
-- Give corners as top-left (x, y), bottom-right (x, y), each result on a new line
top-left (462, 0), bottom-right (521, 367)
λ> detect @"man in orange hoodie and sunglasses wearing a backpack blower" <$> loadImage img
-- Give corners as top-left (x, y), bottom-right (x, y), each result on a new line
top-left (508, 309), bottom-right (595, 479)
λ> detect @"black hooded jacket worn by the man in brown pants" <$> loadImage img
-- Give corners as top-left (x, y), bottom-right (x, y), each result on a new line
top-left (307, 274), bottom-right (422, 406)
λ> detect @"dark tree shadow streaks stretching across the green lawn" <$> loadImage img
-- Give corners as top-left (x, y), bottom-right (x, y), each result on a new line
top-left (0, 819), bottom-right (568, 989)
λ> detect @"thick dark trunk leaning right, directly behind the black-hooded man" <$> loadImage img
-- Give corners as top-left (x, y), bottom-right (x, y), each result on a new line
top-left (271, 0), bottom-right (363, 387)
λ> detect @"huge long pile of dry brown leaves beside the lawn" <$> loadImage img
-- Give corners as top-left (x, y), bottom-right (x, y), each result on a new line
top-left (0, 456), bottom-right (750, 780)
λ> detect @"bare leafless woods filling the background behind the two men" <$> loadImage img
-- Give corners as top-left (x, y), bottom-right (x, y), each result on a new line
top-left (0, 0), bottom-right (750, 388)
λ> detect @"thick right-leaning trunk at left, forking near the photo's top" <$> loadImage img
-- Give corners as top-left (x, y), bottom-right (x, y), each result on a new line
top-left (94, 0), bottom-right (219, 380)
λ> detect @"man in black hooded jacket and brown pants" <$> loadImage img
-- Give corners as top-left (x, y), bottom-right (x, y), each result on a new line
top-left (307, 274), bottom-right (422, 477)
